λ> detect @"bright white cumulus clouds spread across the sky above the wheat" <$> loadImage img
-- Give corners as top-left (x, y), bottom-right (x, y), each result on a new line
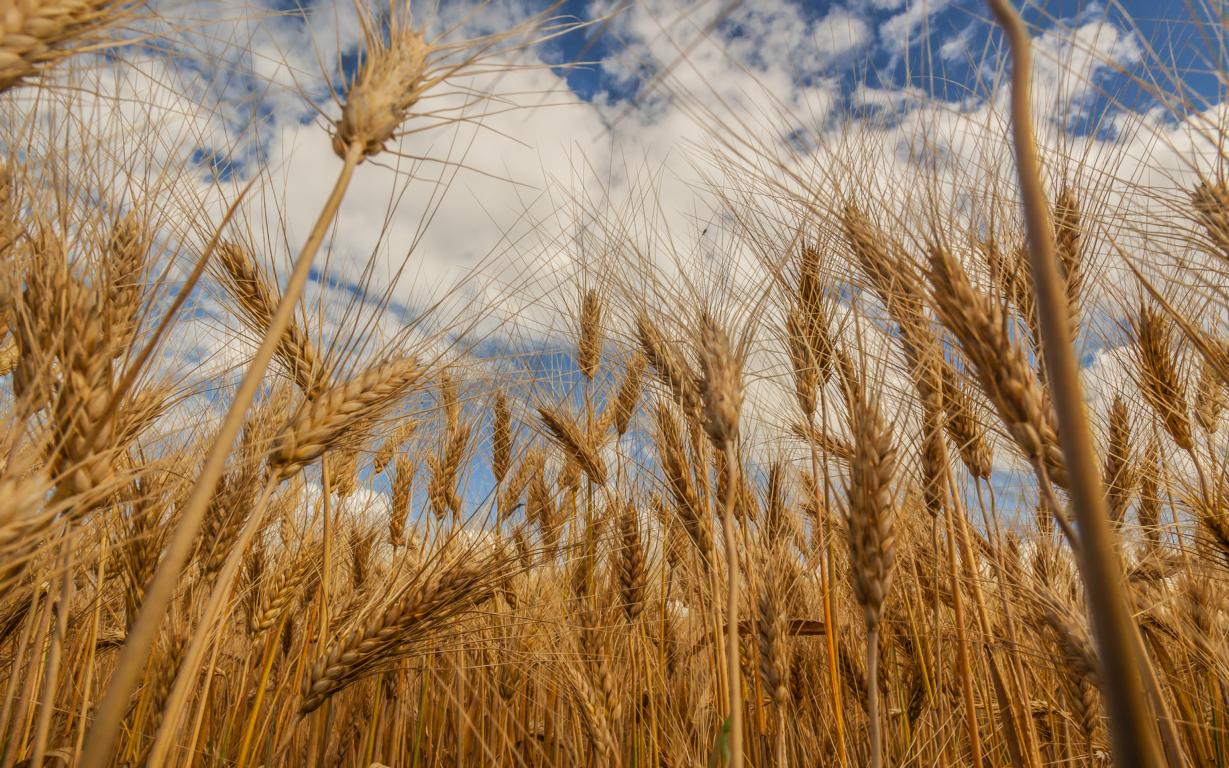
top-left (11, 0), bottom-right (1215, 400)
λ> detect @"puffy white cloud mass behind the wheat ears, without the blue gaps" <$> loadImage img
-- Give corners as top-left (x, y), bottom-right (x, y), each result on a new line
top-left (9, 0), bottom-right (1218, 434)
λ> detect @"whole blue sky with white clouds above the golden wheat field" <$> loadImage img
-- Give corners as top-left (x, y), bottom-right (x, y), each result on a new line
top-left (14, 0), bottom-right (1224, 496)
